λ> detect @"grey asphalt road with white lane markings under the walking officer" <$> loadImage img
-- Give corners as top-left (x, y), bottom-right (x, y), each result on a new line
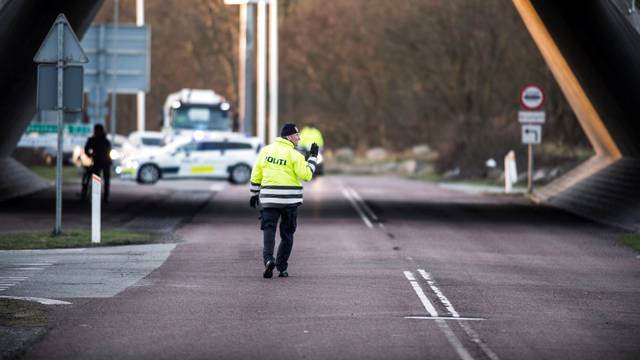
top-left (13, 177), bottom-right (640, 359)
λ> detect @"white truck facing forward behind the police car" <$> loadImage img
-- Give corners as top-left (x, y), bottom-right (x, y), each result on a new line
top-left (162, 89), bottom-right (233, 137)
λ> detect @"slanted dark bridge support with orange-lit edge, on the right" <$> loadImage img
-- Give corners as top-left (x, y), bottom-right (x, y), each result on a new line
top-left (513, 0), bottom-right (640, 231)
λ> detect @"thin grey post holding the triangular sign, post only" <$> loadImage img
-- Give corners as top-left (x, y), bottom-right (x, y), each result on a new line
top-left (53, 22), bottom-right (64, 236)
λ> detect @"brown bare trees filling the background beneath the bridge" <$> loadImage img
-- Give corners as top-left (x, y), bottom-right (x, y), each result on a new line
top-left (90, 0), bottom-right (584, 174)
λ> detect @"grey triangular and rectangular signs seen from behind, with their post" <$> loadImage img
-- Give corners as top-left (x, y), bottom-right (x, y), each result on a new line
top-left (33, 14), bottom-right (88, 236)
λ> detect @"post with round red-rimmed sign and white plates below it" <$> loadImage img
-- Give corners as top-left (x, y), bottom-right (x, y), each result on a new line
top-left (518, 84), bottom-right (545, 194)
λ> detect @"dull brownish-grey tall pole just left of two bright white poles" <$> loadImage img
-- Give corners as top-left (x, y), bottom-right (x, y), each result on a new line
top-left (244, 4), bottom-right (256, 135)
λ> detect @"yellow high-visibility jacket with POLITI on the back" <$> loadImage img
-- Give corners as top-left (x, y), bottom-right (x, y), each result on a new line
top-left (250, 138), bottom-right (317, 207)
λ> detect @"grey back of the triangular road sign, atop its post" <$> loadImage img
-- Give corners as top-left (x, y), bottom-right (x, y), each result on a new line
top-left (33, 14), bottom-right (89, 64)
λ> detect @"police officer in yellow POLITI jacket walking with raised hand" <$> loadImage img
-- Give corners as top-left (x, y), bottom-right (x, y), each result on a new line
top-left (249, 124), bottom-right (318, 278)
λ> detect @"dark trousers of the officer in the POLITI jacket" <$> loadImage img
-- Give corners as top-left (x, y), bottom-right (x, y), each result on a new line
top-left (260, 206), bottom-right (298, 271)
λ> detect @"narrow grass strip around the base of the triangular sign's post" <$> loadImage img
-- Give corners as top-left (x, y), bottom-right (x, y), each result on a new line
top-left (0, 230), bottom-right (157, 250)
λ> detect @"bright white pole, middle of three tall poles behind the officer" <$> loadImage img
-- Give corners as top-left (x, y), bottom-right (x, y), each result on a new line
top-left (256, 1), bottom-right (267, 143)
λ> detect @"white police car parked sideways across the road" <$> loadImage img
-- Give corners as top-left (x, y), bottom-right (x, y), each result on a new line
top-left (115, 134), bottom-right (260, 184)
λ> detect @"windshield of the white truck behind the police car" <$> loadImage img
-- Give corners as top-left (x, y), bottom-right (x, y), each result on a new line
top-left (173, 105), bottom-right (231, 131)
